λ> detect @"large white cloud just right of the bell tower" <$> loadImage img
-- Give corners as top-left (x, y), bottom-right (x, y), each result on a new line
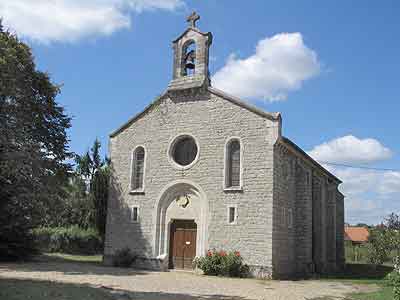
top-left (212, 33), bottom-right (321, 101)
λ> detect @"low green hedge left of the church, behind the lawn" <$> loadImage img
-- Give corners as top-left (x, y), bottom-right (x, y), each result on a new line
top-left (33, 226), bottom-right (103, 254)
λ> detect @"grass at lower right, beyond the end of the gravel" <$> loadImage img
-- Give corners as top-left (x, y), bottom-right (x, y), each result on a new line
top-left (321, 264), bottom-right (393, 300)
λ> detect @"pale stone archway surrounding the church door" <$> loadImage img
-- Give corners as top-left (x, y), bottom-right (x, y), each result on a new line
top-left (154, 180), bottom-right (208, 257)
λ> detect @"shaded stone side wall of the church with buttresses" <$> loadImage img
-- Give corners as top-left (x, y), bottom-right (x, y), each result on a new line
top-left (272, 143), bottom-right (344, 277)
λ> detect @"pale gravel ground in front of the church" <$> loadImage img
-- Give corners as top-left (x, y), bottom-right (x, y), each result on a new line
top-left (0, 262), bottom-right (376, 300)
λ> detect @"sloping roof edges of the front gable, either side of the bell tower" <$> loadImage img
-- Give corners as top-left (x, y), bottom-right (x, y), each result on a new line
top-left (109, 87), bottom-right (281, 137)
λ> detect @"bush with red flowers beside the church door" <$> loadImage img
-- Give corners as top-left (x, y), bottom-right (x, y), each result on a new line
top-left (194, 249), bottom-right (249, 277)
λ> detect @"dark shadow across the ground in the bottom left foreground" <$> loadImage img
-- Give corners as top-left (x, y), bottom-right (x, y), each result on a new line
top-left (0, 277), bottom-right (250, 300)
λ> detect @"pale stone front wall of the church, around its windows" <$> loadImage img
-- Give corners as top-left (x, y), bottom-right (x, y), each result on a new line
top-left (105, 88), bottom-right (279, 270)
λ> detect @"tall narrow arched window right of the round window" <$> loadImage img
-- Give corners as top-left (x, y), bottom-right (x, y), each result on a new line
top-left (225, 139), bottom-right (241, 188)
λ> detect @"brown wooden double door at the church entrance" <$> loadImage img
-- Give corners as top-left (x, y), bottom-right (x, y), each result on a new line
top-left (169, 220), bottom-right (197, 269)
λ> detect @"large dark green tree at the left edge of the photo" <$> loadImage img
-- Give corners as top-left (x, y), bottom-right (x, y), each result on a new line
top-left (0, 22), bottom-right (70, 259)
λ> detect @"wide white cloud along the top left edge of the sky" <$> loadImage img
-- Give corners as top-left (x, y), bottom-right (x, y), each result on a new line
top-left (0, 0), bottom-right (183, 43)
